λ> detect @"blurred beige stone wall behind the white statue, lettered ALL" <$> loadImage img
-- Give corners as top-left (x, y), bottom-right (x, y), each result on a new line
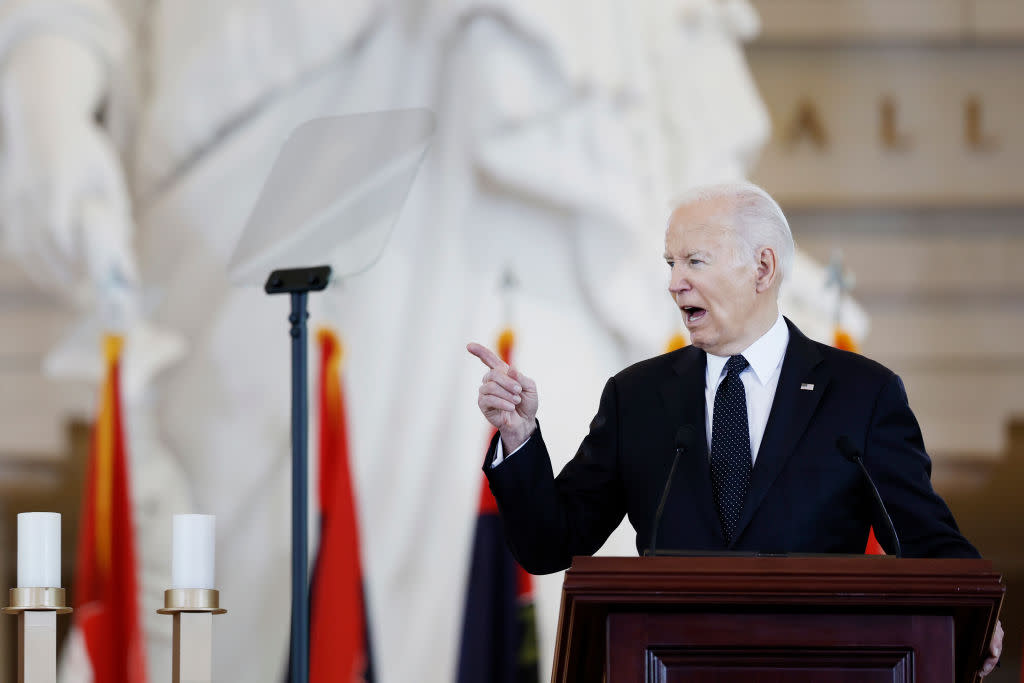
top-left (0, 0), bottom-right (1024, 683)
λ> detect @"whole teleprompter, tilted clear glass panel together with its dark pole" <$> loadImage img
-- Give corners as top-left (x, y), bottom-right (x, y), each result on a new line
top-left (228, 110), bottom-right (434, 683)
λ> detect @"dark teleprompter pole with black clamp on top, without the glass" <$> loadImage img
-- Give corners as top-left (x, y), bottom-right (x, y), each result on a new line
top-left (263, 265), bottom-right (331, 683)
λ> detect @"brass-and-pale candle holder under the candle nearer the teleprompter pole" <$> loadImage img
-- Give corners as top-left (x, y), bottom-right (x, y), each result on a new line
top-left (157, 588), bottom-right (227, 683)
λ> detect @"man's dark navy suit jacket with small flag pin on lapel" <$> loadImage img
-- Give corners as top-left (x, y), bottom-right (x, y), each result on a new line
top-left (484, 321), bottom-right (978, 573)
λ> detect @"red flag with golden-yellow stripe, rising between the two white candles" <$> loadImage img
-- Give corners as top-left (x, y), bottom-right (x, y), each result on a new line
top-left (74, 335), bottom-right (145, 683)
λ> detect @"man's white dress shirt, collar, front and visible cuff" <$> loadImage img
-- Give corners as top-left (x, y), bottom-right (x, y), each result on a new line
top-left (490, 313), bottom-right (790, 467)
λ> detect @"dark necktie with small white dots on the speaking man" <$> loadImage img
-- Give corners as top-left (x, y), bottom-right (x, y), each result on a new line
top-left (711, 355), bottom-right (752, 544)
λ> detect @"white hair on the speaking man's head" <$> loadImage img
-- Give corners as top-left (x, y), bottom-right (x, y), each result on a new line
top-left (676, 182), bottom-right (796, 285)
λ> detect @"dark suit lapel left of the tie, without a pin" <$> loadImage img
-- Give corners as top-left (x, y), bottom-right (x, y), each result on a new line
top-left (662, 347), bottom-right (725, 545)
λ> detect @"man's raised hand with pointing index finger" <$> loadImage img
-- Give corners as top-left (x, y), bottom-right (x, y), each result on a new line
top-left (466, 343), bottom-right (537, 453)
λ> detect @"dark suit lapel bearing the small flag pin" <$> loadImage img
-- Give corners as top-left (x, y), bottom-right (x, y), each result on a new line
top-left (733, 319), bottom-right (828, 544)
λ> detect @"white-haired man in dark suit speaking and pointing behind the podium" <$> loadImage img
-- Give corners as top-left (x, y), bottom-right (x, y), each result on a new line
top-left (468, 183), bottom-right (1002, 675)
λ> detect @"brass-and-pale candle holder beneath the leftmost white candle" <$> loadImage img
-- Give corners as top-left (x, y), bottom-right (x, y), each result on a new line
top-left (4, 588), bottom-right (72, 683)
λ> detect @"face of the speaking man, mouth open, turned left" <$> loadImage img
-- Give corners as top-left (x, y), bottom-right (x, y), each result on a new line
top-left (665, 200), bottom-right (768, 355)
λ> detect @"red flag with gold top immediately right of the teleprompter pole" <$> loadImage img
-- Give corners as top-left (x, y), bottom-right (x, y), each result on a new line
top-left (309, 329), bottom-right (374, 683)
